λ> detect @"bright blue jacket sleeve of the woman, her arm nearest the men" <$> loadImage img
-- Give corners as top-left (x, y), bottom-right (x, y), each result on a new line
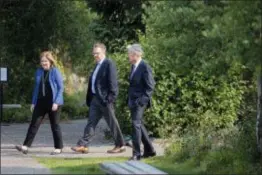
top-left (54, 69), bottom-right (64, 104)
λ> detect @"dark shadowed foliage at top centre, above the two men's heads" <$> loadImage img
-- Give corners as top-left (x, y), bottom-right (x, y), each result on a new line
top-left (86, 0), bottom-right (148, 52)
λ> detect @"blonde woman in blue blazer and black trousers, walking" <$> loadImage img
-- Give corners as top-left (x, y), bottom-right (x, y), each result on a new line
top-left (16, 51), bottom-right (64, 155)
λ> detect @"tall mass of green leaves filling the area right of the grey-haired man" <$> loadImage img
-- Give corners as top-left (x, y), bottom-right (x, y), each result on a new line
top-left (116, 1), bottom-right (261, 134)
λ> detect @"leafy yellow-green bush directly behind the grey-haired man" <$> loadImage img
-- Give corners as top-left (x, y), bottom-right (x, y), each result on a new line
top-left (112, 42), bottom-right (245, 136)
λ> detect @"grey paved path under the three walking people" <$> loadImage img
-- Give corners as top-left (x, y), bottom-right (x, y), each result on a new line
top-left (1, 119), bottom-right (164, 174)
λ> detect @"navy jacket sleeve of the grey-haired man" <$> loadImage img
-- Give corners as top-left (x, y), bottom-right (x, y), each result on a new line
top-left (138, 65), bottom-right (155, 105)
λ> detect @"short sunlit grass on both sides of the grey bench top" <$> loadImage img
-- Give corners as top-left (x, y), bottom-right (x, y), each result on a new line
top-left (36, 156), bottom-right (194, 174)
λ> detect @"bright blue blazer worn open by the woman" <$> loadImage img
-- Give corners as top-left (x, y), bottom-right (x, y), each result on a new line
top-left (32, 67), bottom-right (64, 105)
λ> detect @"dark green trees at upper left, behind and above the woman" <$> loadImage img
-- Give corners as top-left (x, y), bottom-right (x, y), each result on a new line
top-left (1, 0), bottom-right (97, 103)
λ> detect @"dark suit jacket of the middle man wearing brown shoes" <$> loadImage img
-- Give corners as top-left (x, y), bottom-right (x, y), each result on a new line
top-left (86, 58), bottom-right (118, 106)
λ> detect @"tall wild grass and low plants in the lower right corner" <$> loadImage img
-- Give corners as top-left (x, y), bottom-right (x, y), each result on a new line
top-left (166, 115), bottom-right (262, 174)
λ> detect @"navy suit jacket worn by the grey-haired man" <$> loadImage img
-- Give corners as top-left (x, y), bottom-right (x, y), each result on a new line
top-left (128, 60), bottom-right (155, 108)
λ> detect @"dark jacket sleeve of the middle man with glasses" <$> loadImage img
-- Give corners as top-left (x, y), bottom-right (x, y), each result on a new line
top-left (107, 60), bottom-right (118, 103)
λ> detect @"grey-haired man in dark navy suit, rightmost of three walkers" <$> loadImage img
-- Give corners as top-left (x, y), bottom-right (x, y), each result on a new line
top-left (127, 44), bottom-right (156, 160)
